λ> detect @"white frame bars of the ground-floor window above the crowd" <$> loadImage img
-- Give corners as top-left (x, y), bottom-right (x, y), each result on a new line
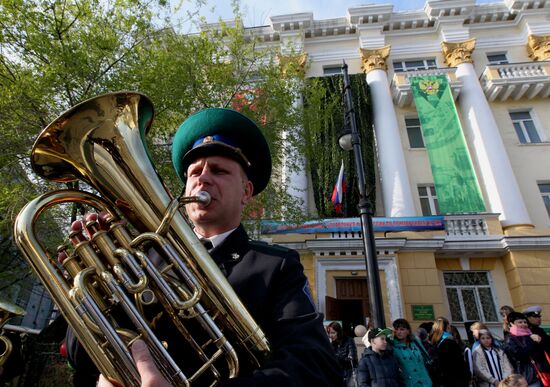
top-left (442, 270), bottom-right (499, 323)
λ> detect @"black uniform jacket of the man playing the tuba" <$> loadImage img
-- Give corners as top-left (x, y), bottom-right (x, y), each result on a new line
top-left (67, 225), bottom-right (342, 387)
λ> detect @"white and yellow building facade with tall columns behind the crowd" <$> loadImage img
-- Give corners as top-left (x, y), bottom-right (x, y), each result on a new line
top-left (243, 0), bottom-right (550, 334)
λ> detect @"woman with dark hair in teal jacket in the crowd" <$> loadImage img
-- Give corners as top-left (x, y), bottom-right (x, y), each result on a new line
top-left (392, 318), bottom-right (432, 387)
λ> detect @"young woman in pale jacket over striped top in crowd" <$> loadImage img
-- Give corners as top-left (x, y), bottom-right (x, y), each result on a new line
top-left (473, 329), bottom-right (513, 387)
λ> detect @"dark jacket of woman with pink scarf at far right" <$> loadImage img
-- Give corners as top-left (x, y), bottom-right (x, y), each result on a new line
top-left (504, 333), bottom-right (550, 384)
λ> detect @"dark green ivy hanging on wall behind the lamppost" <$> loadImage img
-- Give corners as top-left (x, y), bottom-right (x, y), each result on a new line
top-left (304, 73), bottom-right (376, 218)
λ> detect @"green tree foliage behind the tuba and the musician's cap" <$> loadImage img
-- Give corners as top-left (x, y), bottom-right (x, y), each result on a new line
top-left (0, 0), bottom-right (310, 294)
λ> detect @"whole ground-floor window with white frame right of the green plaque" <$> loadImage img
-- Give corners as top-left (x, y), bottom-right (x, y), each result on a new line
top-left (443, 271), bottom-right (499, 322)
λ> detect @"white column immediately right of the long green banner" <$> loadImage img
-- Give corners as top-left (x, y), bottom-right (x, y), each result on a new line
top-left (456, 63), bottom-right (531, 226)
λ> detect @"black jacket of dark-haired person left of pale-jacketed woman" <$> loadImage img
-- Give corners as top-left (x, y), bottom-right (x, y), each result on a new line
top-left (433, 336), bottom-right (470, 387)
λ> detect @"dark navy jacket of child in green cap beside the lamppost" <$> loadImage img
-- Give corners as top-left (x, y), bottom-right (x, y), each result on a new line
top-left (357, 348), bottom-right (404, 387)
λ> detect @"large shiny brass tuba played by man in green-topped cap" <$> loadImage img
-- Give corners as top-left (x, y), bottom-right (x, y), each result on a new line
top-left (14, 92), bottom-right (269, 386)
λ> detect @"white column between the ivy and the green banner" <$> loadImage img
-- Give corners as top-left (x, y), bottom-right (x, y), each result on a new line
top-left (367, 69), bottom-right (416, 217)
